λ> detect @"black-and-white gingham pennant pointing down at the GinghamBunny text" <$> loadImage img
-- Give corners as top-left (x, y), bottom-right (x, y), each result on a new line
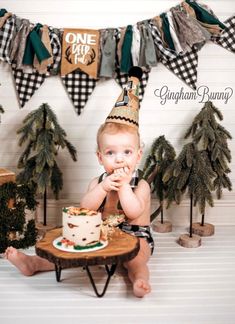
top-left (161, 48), bottom-right (198, 90)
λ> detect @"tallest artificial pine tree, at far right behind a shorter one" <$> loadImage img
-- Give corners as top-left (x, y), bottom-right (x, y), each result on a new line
top-left (185, 101), bottom-right (232, 226)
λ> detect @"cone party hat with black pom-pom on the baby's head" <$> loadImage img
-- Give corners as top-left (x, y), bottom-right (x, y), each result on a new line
top-left (105, 66), bottom-right (143, 128)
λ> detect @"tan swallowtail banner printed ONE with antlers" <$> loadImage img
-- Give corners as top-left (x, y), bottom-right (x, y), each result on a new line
top-left (61, 28), bottom-right (100, 79)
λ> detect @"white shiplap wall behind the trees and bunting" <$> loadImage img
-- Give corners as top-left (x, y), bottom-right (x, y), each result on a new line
top-left (0, 0), bottom-right (235, 224)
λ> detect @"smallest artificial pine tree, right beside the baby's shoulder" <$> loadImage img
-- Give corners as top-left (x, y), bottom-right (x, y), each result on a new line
top-left (143, 135), bottom-right (176, 224)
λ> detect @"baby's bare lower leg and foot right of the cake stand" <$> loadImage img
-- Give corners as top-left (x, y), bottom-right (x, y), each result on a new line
top-left (124, 239), bottom-right (151, 297)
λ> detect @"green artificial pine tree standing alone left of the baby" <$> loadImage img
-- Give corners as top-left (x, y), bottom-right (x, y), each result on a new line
top-left (17, 103), bottom-right (77, 226)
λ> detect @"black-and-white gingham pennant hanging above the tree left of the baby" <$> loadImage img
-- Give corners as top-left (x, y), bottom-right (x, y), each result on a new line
top-left (11, 64), bottom-right (46, 108)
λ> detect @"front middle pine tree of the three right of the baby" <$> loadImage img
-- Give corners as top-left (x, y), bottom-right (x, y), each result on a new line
top-left (163, 142), bottom-right (215, 237)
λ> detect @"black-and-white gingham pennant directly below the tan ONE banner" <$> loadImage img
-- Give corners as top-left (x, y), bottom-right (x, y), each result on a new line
top-left (61, 70), bottom-right (98, 115)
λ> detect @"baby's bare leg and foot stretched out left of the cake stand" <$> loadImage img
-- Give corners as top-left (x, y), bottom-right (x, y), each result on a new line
top-left (5, 246), bottom-right (55, 276)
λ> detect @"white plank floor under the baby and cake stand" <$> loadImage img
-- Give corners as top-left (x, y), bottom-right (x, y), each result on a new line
top-left (0, 226), bottom-right (235, 324)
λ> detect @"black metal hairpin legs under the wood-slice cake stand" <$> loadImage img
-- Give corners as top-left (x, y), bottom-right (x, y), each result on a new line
top-left (55, 264), bottom-right (117, 297)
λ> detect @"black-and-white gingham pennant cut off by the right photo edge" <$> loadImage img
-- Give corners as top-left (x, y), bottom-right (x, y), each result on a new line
top-left (211, 16), bottom-right (235, 53)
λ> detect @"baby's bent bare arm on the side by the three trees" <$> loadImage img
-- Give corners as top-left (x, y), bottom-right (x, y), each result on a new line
top-left (118, 179), bottom-right (150, 219)
